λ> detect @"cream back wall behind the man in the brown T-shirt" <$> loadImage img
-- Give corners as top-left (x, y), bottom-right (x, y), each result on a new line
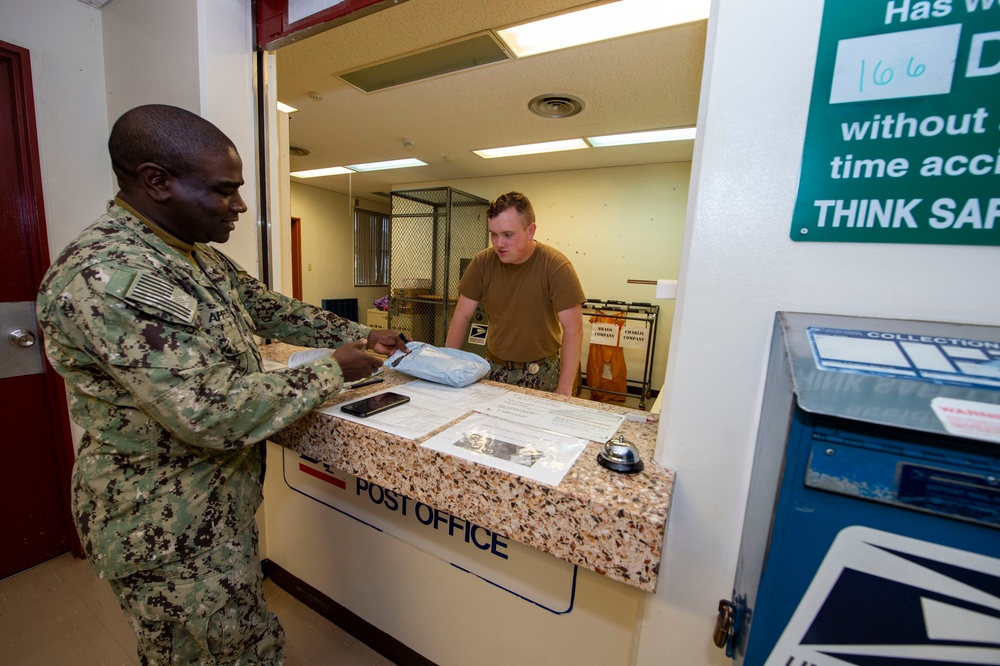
top-left (393, 162), bottom-right (691, 390)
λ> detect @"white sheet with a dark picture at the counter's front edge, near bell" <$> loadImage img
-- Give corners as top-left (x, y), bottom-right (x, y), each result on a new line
top-left (423, 414), bottom-right (587, 486)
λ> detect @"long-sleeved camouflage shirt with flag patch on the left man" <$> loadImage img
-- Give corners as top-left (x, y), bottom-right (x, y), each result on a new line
top-left (37, 203), bottom-right (370, 578)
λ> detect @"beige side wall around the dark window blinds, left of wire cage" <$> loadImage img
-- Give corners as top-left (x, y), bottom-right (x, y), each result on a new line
top-left (286, 182), bottom-right (389, 316)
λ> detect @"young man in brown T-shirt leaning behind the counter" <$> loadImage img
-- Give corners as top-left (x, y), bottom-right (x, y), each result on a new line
top-left (445, 192), bottom-right (587, 395)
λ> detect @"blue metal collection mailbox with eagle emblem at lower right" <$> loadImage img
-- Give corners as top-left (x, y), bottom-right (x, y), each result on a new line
top-left (716, 312), bottom-right (1000, 666)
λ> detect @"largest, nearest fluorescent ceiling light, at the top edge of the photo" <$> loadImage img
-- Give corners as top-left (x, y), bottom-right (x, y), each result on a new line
top-left (497, 0), bottom-right (711, 58)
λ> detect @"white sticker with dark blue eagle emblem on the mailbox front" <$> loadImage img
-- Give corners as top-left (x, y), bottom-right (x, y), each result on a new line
top-left (765, 525), bottom-right (1000, 666)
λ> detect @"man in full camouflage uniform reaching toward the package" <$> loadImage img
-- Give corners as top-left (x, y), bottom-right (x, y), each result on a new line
top-left (37, 105), bottom-right (405, 664)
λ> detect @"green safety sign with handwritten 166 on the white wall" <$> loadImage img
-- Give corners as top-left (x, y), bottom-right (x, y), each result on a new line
top-left (791, 0), bottom-right (1000, 245)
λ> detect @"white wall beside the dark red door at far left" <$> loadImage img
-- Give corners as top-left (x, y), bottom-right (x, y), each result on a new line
top-left (0, 0), bottom-right (117, 259)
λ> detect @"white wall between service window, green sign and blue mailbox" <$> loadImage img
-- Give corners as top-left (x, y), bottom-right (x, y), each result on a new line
top-left (639, 0), bottom-right (1000, 666)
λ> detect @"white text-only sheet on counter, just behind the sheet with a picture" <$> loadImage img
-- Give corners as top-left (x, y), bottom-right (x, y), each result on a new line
top-left (476, 391), bottom-right (625, 444)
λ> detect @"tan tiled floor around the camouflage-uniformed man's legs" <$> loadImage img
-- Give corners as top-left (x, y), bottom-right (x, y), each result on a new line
top-left (0, 554), bottom-right (392, 666)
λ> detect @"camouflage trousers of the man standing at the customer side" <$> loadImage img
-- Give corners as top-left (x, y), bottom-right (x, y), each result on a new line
top-left (110, 523), bottom-right (285, 665)
